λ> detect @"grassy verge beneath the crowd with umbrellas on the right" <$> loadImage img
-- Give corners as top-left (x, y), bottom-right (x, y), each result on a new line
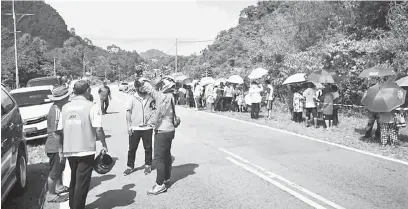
top-left (194, 103), bottom-right (408, 162)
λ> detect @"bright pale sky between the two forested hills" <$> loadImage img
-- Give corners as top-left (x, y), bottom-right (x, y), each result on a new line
top-left (45, 0), bottom-right (257, 55)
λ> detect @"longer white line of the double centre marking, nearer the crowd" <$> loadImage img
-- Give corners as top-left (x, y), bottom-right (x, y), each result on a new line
top-left (219, 148), bottom-right (345, 209)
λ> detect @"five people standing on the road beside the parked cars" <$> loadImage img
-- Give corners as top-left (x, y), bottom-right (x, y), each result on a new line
top-left (45, 78), bottom-right (180, 209)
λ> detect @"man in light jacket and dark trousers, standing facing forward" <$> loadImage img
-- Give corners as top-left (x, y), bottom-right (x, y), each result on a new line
top-left (124, 78), bottom-right (156, 175)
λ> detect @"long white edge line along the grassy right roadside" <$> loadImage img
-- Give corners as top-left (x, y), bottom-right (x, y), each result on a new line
top-left (190, 108), bottom-right (408, 166)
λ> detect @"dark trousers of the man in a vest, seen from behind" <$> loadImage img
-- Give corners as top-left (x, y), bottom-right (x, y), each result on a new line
top-left (68, 155), bottom-right (95, 209)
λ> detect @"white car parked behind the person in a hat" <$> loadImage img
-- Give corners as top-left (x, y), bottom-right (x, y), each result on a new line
top-left (10, 86), bottom-right (53, 141)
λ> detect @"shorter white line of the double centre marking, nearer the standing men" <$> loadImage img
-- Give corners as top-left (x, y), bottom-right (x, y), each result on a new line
top-left (227, 157), bottom-right (326, 209)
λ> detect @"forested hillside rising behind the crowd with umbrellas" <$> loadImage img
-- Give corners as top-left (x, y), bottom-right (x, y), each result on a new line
top-left (173, 1), bottom-right (408, 104)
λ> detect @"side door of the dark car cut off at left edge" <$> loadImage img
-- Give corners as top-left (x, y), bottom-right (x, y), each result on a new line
top-left (1, 88), bottom-right (16, 188)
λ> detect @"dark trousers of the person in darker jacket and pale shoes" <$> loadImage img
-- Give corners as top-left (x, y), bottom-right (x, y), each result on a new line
top-left (154, 131), bottom-right (175, 185)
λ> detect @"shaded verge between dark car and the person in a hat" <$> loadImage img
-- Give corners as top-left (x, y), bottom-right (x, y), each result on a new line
top-left (2, 140), bottom-right (48, 209)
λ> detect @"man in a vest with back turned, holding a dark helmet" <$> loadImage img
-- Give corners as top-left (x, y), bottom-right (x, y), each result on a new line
top-left (57, 80), bottom-right (108, 209)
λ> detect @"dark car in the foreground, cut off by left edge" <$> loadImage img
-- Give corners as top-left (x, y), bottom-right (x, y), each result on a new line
top-left (1, 85), bottom-right (28, 203)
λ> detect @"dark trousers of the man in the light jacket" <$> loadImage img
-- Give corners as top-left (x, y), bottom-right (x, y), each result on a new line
top-left (127, 129), bottom-right (153, 168)
